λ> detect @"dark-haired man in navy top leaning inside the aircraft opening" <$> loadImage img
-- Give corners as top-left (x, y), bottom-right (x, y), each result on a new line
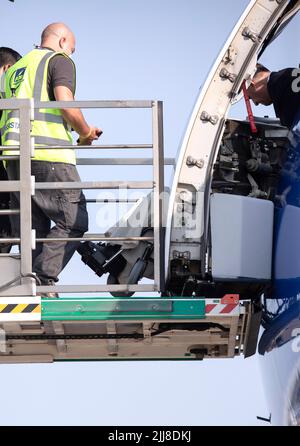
top-left (248, 64), bottom-right (300, 129)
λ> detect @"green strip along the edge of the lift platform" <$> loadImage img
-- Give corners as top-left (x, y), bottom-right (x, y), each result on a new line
top-left (42, 298), bottom-right (205, 321)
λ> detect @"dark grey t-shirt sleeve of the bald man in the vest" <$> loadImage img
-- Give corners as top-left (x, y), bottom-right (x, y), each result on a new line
top-left (47, 54), bottom-right (76, 101)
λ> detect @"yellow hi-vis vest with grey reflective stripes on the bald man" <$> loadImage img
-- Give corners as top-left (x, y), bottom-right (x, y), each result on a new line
top-left (0, 50), bottom-right (76, 164)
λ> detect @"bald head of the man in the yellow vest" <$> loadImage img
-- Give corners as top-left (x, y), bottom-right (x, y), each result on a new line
top-left (41, 23), bottom-right (75, 56)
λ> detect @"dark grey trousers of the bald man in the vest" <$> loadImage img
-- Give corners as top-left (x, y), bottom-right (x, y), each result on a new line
top-left (7, 161), bottom-right (88, 284)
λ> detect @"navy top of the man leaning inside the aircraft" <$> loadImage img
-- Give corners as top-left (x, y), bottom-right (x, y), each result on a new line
top-left (268, 68), bottom-right (300, 128)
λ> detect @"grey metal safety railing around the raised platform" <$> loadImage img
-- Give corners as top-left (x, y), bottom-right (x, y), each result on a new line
top-left (0, 99), bottom-right (168, 296)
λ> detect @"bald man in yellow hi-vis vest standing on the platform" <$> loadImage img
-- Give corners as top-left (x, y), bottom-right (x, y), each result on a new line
top-left (3, 23), bottom-right (102, 297)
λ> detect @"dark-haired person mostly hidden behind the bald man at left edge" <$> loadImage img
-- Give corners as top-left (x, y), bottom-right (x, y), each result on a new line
top-left (0, 47), bottom-right (21, 253)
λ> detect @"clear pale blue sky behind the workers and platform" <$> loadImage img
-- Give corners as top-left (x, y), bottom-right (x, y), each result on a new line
top-left (0, 0), bottom-right (300, 425)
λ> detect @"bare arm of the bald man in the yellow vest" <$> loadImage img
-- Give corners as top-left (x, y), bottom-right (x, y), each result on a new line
top-left (54, 86), bottom-right (102, 145)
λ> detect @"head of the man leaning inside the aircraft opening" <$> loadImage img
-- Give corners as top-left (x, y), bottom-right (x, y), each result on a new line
top-left (248, 64), bottom-right (273, 105)
